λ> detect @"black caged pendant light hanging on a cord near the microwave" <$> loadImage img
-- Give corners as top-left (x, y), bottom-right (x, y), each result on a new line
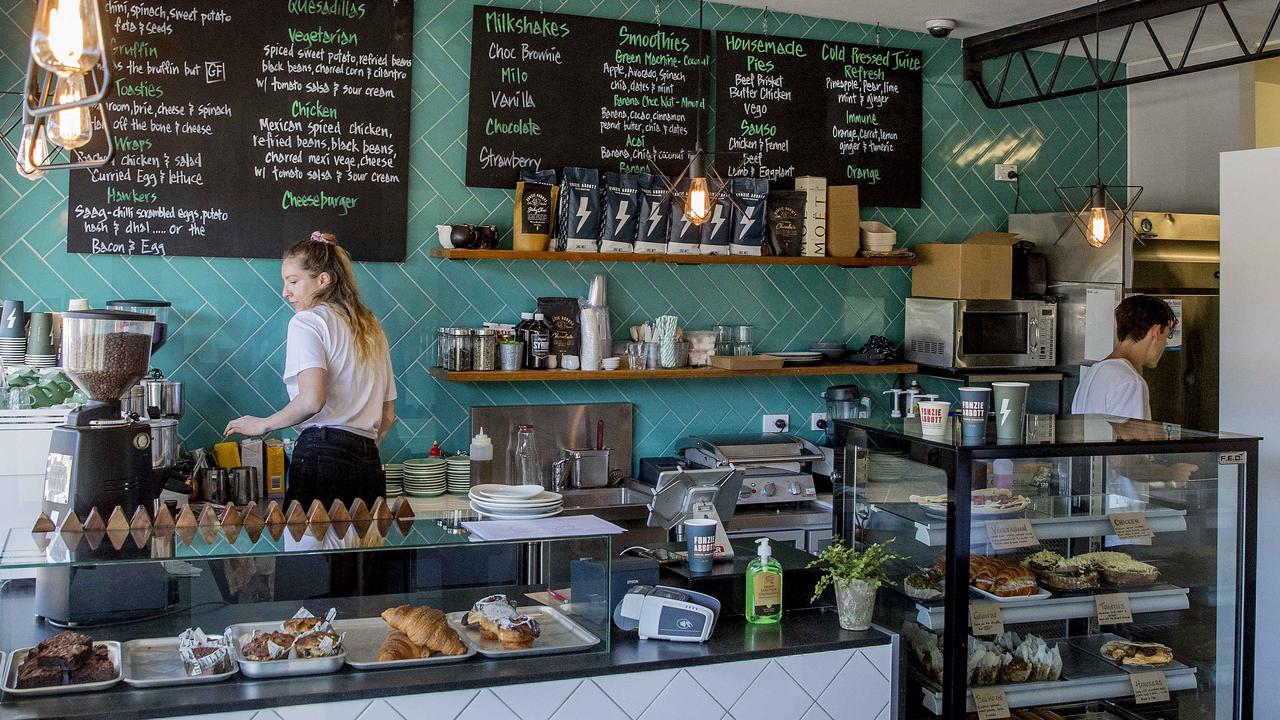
top-left (1055, 0), bottom-right (1142, 247)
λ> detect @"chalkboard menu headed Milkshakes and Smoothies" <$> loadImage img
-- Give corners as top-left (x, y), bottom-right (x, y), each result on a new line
top-left (467, 5), bottom-right (710, 187)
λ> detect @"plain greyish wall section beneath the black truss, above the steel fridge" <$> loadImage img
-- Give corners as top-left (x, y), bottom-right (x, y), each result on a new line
top-left (1129, 64), bottom-right (1253, 214)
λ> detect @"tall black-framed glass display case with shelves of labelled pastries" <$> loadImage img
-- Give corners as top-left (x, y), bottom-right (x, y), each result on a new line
top-left (835, 415), bottom-right (1258, 720)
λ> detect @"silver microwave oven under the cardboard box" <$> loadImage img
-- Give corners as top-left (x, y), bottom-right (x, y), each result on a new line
top-left (905, 297), bottom-right (1057, 370)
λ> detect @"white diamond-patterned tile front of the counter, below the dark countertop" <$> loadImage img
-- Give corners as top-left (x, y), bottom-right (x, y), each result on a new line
top-left (177, 646), bottom-right (893, 720)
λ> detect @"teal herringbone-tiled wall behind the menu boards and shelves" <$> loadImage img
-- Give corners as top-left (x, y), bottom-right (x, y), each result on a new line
top-left (0, 0), bottom-right (1126, 460)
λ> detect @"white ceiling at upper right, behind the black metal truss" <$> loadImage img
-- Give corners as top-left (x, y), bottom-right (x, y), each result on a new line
top-left (717, 0), bottom-right (1280, 64)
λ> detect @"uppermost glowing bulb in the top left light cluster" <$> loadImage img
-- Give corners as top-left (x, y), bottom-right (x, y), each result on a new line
top-left (31, 0), bottom-right (102, 76)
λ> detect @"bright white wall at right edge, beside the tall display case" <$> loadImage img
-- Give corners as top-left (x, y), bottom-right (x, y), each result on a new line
top-left (1219, 142), bottom-right (1280, 717)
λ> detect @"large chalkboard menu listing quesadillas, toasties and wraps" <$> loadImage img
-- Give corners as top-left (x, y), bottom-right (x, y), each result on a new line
top-left (67, 0), bottom-right (413, 261)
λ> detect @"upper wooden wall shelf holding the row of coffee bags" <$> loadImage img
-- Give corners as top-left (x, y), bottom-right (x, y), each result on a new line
top-left (431, 247), bottom-right (915, 268)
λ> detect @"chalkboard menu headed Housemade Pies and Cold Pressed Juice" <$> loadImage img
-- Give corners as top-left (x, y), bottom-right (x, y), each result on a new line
top-left (716, 32), bottom-right (924, 208)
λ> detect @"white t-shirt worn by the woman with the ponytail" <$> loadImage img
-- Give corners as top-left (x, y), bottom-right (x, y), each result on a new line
top-left (284, 305), bottom-right (396, 438)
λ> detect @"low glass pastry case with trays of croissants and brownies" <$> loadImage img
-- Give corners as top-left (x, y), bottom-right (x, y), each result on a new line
top-left (0, 505), bottom-right (612, 702)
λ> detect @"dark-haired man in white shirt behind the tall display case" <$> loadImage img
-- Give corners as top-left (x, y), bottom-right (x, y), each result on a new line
top-left (1071, 295), bottom-right (1178, 420)
